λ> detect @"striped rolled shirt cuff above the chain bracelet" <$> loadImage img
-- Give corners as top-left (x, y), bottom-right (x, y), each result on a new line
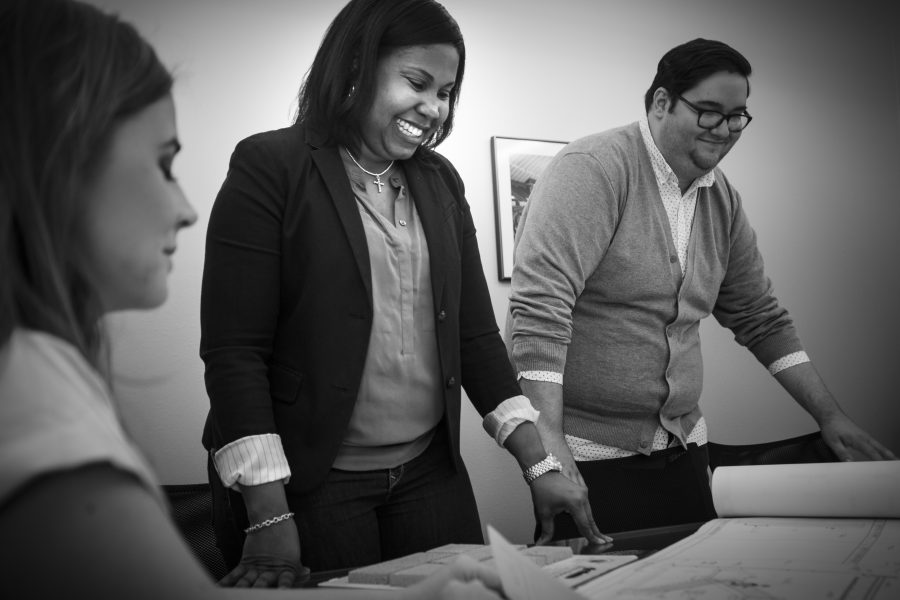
top-left (213, 433), bottom-right (291, 491)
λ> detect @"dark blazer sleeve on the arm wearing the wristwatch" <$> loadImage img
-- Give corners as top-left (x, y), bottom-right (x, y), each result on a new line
top-left (444, 160), bottom-right (522, 417)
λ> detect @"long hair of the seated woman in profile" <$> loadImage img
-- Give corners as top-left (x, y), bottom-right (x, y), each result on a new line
top-left (0, 0), bottom-right (172, 365)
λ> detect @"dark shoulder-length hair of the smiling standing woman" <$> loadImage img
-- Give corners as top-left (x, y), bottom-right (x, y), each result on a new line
top-left (297, 0), bottom-right (466, 154)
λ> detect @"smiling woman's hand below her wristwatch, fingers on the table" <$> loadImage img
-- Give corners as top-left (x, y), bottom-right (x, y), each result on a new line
top-left (530, 471), bottom-right (612, 545)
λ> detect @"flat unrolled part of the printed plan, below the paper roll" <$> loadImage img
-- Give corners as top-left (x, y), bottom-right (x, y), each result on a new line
top-left (578, 518), bottom-right (900, 600)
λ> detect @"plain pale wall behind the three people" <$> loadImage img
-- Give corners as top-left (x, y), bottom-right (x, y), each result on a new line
top-left (93, 0), bottom-right (900, 542)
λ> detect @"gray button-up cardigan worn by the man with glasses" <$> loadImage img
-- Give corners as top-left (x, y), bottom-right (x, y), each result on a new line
top-left (507, 123), bottom-right (802, 454)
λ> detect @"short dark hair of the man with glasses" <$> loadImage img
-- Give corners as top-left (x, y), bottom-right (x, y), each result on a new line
top-left (644, 38), bottom-right (752, 112)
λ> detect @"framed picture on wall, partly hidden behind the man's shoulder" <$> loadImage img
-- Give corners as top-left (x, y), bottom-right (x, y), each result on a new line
top-left (491, 136), bottom-right (567, 281)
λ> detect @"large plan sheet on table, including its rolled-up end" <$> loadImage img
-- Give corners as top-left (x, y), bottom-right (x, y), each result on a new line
top-left (578, 461), bottom-right (900, 600)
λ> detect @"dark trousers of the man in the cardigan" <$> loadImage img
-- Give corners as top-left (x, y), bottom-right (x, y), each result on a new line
top-left (538, 444), bottom-right (716, 540)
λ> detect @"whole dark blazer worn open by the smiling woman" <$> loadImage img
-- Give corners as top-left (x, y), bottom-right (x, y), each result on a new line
top-left (200, 125), bottom-right (521, 493)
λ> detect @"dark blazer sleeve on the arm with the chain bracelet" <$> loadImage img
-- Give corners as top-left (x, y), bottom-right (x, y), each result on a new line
top-left (200, 134), bottom-right (289, 447)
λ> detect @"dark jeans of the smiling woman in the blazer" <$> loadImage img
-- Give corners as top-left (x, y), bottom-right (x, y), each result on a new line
top-left (209, 427), bottom-right (484, 571)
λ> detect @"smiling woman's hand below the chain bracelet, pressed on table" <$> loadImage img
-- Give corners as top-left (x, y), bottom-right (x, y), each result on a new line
top-left (219, 519), bottom-right (309, 588)
